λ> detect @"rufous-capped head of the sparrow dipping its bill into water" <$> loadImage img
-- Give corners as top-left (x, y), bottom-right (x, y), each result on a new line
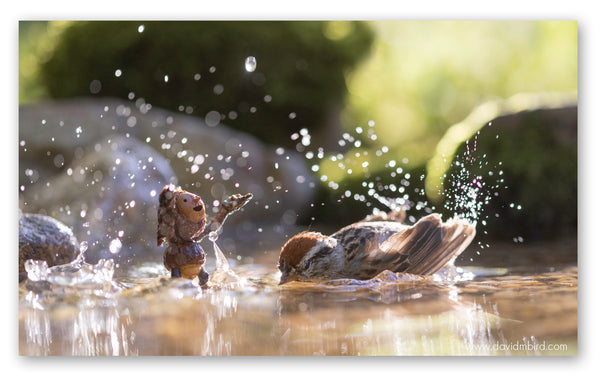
top-left (278, 232), bottom-right (337, 284)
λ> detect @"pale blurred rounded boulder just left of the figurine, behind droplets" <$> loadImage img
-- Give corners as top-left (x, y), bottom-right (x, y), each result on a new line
top-left (22, 135), bottom-right (175, 263)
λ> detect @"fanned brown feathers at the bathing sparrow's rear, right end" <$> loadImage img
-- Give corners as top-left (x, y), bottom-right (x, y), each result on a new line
top-left (378, 214), bottom-right (475, 275)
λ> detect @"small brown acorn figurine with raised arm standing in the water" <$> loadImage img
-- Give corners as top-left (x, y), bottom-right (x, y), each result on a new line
top-left (157, 184), bottom-right (252, 286)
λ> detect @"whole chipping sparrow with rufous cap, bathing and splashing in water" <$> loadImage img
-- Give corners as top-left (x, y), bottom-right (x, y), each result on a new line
top-left (279, 210), bottom-right (475, 284)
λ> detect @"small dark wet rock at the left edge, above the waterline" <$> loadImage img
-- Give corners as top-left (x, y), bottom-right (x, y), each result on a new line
top-left (19, 212), bottom-right (79, 281)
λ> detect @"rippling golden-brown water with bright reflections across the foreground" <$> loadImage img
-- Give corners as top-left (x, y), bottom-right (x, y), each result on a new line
top-left (19, 258), bottom-right (577, 356)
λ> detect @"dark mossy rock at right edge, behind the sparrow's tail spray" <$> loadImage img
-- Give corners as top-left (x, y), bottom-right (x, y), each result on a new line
top-left (444, 106), bottom-right (577, 241)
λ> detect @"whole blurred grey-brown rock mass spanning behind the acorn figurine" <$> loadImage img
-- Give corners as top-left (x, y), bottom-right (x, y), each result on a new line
top-left (19, 99), bottom-right (316, 261)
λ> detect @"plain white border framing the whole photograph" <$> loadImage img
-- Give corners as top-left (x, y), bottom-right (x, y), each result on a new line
top-left (0, 0), bottom-right (600, 377)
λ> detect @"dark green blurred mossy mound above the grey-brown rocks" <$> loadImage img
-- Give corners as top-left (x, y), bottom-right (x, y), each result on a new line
top-left (41, 21), bottom-right (373, 146)
